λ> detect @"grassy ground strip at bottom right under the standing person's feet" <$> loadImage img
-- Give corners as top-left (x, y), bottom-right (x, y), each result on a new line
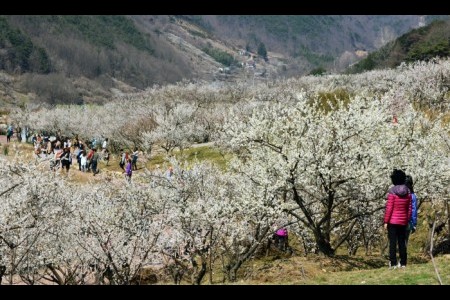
top-left (229, 255), bottom-right (450, 285)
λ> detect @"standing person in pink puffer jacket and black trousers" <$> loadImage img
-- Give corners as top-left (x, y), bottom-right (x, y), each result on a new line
top-left (384, 169), bottom-right (412, 269)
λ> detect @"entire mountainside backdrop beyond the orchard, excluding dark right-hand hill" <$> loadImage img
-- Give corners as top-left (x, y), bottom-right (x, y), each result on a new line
top-left (0, 15), bottom-right (441, 112)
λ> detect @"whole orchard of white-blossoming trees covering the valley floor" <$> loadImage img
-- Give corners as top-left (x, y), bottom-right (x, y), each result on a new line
top-left (0, 60), bottom-right (450, 284)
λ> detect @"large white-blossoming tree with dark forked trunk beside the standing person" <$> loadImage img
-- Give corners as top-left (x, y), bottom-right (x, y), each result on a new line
top-left (223, 94), bottom-right (449, 255)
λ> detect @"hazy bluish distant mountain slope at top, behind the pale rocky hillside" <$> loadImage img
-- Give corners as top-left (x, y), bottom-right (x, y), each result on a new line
top-left (144, 15), bottom-right (446, 77)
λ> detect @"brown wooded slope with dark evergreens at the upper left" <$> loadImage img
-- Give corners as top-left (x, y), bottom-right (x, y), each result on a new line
top-left (0, 15), bottom-right (195, 104)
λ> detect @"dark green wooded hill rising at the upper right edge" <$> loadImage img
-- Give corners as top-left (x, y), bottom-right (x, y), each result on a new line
top-left (348, 20), bottom-right (450, 73)
